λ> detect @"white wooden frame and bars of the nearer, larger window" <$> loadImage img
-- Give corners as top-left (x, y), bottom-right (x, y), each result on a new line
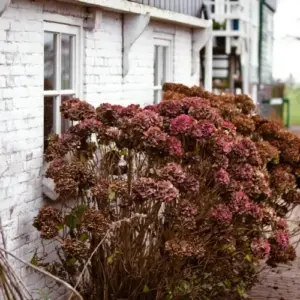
top-left (44, 21), bottom-right (82, 135)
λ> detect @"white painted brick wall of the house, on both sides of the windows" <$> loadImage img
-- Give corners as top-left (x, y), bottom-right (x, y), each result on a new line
top-left (0, 0), bottom-right (199, 299)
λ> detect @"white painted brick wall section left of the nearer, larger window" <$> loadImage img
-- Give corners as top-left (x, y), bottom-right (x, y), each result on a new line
top-left (0, 1), bottom-right (82, 299)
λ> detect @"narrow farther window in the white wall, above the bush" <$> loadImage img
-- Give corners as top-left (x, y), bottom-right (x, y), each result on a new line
top-left (153, 39), bottom-right (172, 104)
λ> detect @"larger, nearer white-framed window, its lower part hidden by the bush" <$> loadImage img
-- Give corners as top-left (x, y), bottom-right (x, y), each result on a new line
top-left (44, 22), bottom-right (80, 147)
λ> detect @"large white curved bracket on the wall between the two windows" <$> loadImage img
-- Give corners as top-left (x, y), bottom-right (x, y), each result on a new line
top-left (123, 13), bottom-right (150, 77)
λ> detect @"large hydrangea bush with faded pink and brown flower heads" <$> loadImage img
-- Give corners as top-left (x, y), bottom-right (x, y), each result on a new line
top-left (34, 84), bottom-right (300, 300)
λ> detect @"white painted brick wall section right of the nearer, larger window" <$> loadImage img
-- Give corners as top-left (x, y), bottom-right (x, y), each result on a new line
top-left (84, 12), bottom-right (199, 105)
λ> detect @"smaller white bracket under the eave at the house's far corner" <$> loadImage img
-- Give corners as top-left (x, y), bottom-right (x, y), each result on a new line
top-left (192, 26), bottom-right (213, 76)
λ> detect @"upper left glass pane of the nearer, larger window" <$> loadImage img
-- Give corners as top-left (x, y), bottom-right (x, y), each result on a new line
top-left (44, 32), bottom-right (57, 90)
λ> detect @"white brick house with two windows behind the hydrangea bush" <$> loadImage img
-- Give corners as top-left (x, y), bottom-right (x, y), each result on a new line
top-left (0, 0), bottom-right (212, 296)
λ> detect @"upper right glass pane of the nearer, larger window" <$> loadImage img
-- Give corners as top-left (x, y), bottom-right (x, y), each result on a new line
top-left (61, 34), bottom-right (74, 90)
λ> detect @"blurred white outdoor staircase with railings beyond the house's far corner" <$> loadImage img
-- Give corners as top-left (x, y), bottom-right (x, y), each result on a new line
top-left (204, 0), bottom-right (259, 94)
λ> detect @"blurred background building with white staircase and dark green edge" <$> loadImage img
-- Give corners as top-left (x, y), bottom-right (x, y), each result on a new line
top-left (203, 0), bottom-right (277, 102)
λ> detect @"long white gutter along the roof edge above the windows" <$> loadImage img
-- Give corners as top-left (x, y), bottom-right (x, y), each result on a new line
top-left (55, 0), bottom-right (212, 28)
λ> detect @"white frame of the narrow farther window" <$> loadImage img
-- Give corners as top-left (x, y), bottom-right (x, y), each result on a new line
top-left (153, 34), bottom-right (173, 104)
